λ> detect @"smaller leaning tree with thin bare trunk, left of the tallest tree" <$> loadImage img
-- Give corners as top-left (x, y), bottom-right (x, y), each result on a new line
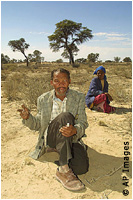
top-left (8, 38), bottom-right (30, 67)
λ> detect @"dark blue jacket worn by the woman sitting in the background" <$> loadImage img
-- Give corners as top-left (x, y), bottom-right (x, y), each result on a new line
top-left (85, 77), bottom-right (109, 107)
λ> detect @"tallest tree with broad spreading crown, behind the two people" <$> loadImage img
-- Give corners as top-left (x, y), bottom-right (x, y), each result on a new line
top-left (48, 19), bottom-right (93, 64)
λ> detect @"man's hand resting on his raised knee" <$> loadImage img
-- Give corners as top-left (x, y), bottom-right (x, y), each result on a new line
top-left (59, 125), bottom-right (77, 137)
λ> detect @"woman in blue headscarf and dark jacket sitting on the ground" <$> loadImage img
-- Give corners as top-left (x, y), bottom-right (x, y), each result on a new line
top-left (85, 66), bottom-right (115, 113)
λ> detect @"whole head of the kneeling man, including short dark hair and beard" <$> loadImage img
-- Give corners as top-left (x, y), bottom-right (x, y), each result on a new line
top-left (50, 68), bottom-right (71, 98)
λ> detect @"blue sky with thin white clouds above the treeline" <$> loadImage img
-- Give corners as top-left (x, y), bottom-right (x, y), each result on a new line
top-left (1, 1), bottom-right (132, 61)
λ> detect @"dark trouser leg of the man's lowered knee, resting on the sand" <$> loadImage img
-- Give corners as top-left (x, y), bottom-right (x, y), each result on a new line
top-left (69, 143), bottom-right (89, 175)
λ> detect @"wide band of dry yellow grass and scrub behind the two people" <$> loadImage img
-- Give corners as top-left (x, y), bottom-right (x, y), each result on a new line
top-left (1, 63), bottom-right (132, 107)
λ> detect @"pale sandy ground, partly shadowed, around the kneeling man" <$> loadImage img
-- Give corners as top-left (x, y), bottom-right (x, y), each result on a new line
top-left (1, 88), bottom-right (132, 199)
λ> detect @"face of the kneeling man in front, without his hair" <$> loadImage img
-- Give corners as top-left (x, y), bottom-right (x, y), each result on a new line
top-left (50, 72), bottom-right (71, 97)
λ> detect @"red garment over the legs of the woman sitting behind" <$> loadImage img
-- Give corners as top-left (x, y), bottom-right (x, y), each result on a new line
top-left (93, 94), bottom-right (115, 113)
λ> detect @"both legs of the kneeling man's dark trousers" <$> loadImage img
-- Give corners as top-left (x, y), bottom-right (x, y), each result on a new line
top-left (47, 112), bottom-right (89, 175)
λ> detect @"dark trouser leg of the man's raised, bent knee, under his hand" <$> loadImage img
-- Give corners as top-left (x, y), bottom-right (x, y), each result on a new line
top-left (47, 112), bottom-right (74, 166)
